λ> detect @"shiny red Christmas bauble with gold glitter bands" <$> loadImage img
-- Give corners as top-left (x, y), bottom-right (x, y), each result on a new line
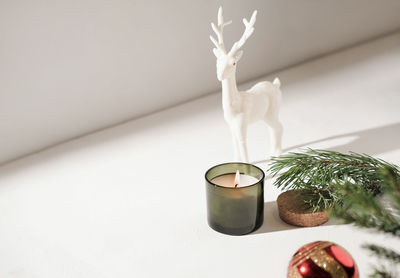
top-left (287, 241), bottom-right (359, 278)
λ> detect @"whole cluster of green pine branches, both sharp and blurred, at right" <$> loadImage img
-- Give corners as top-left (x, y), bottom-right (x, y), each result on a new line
top-left (269, 149), bottom-right (400, 278)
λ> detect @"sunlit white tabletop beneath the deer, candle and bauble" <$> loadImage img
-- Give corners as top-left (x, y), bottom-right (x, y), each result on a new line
top-left (0, 33), bottom-right (400, 278)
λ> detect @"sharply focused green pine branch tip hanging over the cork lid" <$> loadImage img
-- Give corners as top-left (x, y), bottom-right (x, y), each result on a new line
top-left (268, 149), bottom-right (399, 211)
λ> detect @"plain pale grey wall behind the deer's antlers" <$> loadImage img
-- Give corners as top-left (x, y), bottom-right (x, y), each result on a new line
top-left (0, 0), bottom-right (400, 162)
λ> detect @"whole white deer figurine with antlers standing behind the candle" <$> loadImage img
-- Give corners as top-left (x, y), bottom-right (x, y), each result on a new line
top-left (210, 7), bottom-right (283, 162)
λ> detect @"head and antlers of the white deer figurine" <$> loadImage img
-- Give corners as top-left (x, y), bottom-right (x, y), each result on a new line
top-left (210, 7), bottom-right (257, 81)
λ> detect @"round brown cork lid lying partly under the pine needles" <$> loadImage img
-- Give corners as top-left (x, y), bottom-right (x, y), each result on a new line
top-left (277, 190), bottom-right (329, 227)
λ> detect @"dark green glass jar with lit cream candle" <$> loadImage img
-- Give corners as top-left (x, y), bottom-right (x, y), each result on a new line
top-left (205, 162), bottom-right (264, 235)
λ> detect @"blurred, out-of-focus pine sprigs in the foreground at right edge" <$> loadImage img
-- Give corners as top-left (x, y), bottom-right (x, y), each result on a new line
top-left (332, 165), bottom-right (400, 278)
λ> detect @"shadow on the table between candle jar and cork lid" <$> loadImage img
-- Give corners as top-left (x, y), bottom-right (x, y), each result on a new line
top-left (251, 201), bottom-right (340, 234)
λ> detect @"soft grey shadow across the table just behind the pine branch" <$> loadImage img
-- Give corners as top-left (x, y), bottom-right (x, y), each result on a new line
top-left (252, 123), bottom-right (400, 164)
